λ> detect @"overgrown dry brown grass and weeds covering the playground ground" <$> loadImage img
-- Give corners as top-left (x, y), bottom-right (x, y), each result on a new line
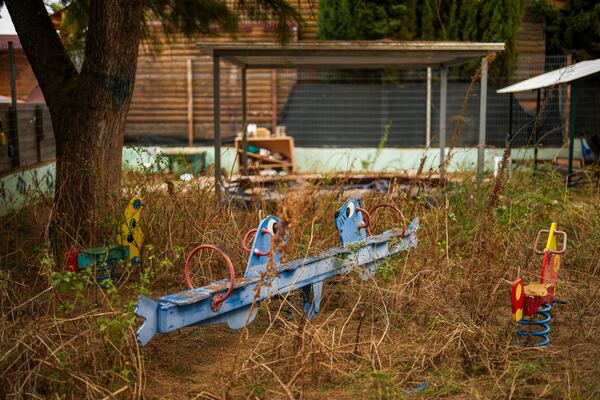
top-left (0, 165), bottom-right (600, 399)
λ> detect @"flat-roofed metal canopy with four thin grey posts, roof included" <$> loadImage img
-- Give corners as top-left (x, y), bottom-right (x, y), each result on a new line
top-left (203, 41), bottom-right (505, 202)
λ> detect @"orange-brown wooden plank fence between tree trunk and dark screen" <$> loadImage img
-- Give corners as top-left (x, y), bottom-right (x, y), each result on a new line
top-left (125, 23), bottom-right (304, 144)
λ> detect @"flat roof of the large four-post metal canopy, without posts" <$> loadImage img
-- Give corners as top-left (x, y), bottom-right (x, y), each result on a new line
top-left (197, 41), bottom-right (504, 68)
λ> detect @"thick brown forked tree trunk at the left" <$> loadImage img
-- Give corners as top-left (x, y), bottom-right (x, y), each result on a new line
top-left (6, 0), bottom-right (143, 259)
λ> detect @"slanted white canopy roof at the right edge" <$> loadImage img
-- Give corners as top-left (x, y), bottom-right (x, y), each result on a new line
top-left (498, 59), bottom-right (600, 93)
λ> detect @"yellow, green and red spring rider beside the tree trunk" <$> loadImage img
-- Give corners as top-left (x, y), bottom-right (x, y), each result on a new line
top-left (65, 197), bottom-right (144, 286)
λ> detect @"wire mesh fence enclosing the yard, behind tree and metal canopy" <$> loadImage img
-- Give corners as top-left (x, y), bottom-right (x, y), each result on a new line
top-left (0, 48), bottom-right (600, 178)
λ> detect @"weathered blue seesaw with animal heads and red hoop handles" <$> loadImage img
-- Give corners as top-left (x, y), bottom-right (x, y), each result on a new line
top-left (135, 199), bottom-right (419, 346)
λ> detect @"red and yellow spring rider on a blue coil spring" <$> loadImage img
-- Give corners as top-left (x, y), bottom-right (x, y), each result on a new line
top-left (511, 223), bottom-right (567, 346)
